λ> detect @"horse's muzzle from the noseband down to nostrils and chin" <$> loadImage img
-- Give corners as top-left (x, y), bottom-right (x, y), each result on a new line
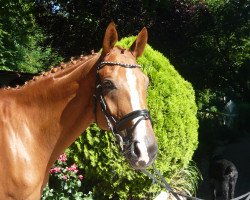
top-left (115, 110), bottom-right (158, 169)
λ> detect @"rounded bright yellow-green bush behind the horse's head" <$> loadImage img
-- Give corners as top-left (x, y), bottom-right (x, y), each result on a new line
top-left (69, 37), bottom-right (198, 199)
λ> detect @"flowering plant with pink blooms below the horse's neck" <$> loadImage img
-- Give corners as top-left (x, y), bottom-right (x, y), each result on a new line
top-left (41, 153), bottom-right (92, 200)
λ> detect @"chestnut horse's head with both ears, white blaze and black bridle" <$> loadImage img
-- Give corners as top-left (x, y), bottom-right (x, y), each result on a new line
top-left (95, 23), bottom-right (158, 169)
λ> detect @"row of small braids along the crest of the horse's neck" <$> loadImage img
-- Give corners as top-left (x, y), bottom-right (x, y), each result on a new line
top-left (3, 52), bottom-right (97, 90)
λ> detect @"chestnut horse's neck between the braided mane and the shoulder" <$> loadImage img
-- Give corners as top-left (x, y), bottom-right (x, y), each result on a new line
top-left (17, 55), bottom-right (99, 166)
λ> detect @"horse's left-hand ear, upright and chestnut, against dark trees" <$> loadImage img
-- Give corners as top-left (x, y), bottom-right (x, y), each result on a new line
top-left (102, 22), bottom-right (118, 55)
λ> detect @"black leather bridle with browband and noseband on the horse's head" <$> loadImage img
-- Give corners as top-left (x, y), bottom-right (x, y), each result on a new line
top-left (94, 61), bottom-right (152, 152)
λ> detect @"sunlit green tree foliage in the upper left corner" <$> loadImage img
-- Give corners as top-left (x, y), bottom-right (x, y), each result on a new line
top-left (0, 0), bottom-right (59, 73)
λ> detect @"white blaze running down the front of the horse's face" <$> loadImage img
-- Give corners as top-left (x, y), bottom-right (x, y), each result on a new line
top-left (126, 69), bottom-right (149, 163)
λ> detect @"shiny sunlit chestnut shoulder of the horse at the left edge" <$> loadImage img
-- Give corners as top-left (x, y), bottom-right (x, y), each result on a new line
top-left (0, 95), bottom-right (42, 199)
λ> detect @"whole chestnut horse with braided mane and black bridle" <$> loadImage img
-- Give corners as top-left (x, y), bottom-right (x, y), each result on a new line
top-left (0, 23), bottom-right (158, 200)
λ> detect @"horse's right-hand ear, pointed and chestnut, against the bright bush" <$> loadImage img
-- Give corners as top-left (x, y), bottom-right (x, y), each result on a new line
top-left (129, 27), bottom-right (148, 57)
